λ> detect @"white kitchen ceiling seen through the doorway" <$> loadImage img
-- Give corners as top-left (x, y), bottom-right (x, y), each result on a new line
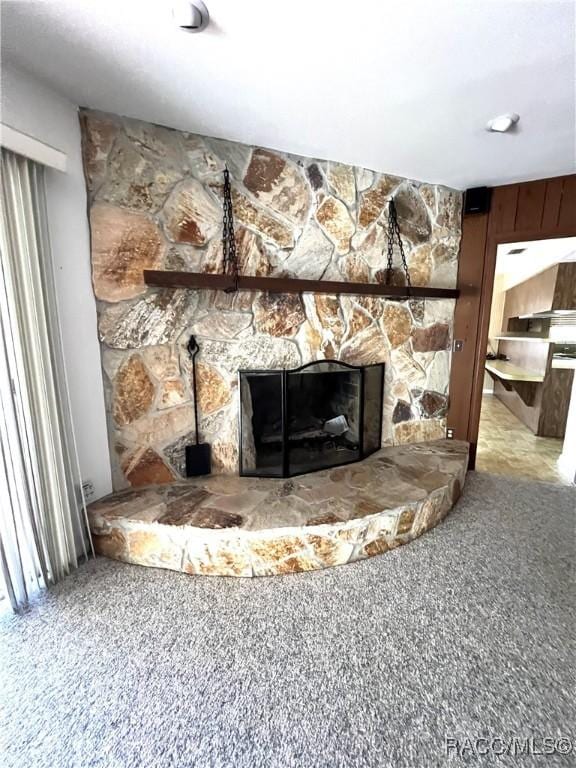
top-left (495, 237), bottom-right (576, 291)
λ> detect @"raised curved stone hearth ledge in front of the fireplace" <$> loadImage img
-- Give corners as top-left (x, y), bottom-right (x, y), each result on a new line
top-left (88, 440), bottom-right (468, 576)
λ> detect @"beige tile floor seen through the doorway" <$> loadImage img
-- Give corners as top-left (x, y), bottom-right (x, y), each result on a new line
top-left (476, 395), bottom-right (570, 485)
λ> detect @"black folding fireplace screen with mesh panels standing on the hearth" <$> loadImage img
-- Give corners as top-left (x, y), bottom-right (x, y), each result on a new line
top-left (239, 360), bottom-right (384, 477)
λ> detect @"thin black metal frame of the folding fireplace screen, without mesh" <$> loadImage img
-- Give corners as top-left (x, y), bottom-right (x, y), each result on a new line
top-left (238, 359), bottom-right (385, 478)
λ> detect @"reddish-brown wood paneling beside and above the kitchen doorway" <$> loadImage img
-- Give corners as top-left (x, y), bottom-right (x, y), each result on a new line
top-left (448, 175), bottom-right (576, 466)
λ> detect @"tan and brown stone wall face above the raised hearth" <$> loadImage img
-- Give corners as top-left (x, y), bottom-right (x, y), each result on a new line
top-left (81, 111), bottom-right (461, 490)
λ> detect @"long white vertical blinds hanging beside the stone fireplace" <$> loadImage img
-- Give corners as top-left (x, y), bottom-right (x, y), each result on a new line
top-left (0, 149), bottom-right (92, 610)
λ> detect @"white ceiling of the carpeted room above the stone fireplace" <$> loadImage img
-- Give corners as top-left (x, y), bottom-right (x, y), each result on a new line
top-left (1, 0), bottom-right (575, 188)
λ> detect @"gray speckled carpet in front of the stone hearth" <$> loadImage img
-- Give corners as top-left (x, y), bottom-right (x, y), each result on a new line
top-left (0, 474), bottom-right (576, 768)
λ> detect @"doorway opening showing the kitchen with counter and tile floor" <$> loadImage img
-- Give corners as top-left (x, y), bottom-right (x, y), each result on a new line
top-left (476, 237), bottom-right (576, 484)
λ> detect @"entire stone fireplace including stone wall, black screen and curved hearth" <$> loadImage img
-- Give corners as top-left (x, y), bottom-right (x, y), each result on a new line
top-left (81, 111), bottom-right (468, 576)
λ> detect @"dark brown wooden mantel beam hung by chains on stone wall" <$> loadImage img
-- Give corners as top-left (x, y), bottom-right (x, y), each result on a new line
top-left (144, 269), bottom-right (460, 299)
